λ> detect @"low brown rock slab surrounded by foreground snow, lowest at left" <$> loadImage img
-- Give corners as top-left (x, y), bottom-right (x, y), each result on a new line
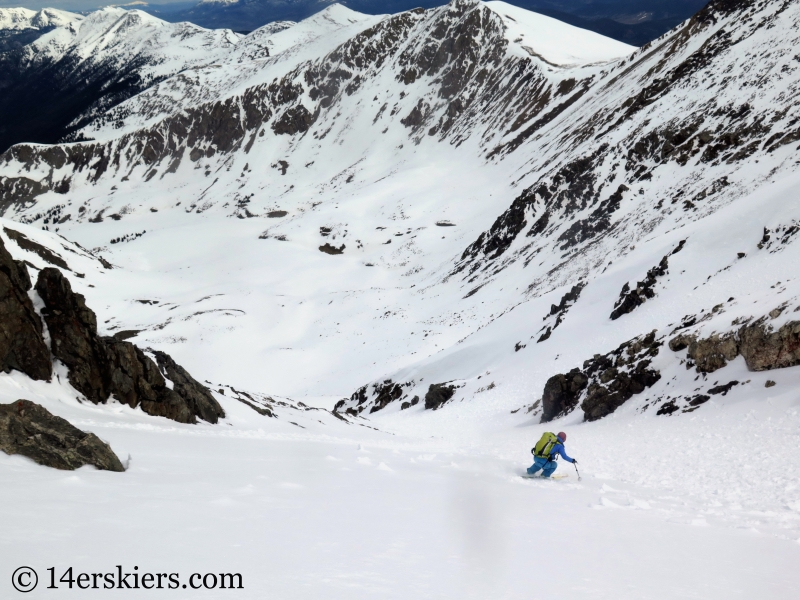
top-left (0, 400), bottom-right (125, 472)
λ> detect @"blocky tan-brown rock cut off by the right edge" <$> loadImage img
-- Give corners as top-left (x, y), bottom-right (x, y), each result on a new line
top-left (739, 321), bottom-right (800, 371)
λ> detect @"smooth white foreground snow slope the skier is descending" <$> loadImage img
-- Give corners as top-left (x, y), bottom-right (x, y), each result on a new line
top-left (0, 382), bottom-right (800, 600)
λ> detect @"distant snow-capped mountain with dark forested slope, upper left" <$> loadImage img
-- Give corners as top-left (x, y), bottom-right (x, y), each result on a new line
top-left (0, 8), bottom-right (241, 149)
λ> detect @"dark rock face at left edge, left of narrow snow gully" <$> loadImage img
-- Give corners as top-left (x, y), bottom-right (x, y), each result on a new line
top-left (0, 238), bottom-right (52, 380)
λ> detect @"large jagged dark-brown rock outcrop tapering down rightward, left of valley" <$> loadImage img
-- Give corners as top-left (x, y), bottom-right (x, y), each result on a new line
top-left (36, 268), bottom-right (224, 423)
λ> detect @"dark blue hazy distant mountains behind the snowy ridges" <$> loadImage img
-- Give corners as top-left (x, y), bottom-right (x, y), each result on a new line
top-left (142, 0), bottom-right (706, 46)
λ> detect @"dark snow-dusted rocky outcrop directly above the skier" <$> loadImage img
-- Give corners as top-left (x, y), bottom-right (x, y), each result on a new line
top-left (542, 332), bottom-right (663, 423)
